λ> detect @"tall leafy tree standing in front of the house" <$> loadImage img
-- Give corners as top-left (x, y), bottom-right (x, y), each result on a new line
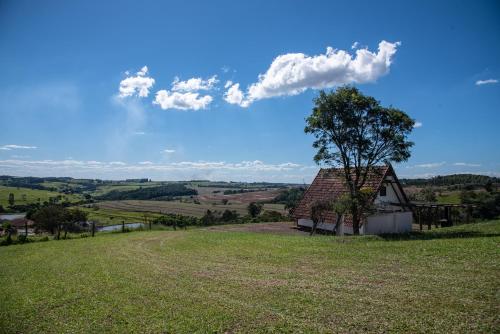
top-left (304, 86), bottom-right (415, 234)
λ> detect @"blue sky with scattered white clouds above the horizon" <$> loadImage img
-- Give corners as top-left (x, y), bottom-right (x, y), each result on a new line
top-left (0, 1), bottom-right (500, 182)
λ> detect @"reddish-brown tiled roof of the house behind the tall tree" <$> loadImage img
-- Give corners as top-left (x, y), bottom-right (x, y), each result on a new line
top-left (293, 166), bottom-right (394, 223)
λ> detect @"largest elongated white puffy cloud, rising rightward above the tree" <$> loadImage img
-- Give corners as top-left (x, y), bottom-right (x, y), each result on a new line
top-left (225, 41), bottom-right (401, 107)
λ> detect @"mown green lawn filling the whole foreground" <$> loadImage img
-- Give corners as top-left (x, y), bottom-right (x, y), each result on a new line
top-left (0, 221), bottom-right (500, 333)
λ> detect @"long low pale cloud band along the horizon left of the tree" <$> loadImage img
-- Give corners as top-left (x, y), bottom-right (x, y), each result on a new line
top-left (0, 159), bottom-right (318, 183)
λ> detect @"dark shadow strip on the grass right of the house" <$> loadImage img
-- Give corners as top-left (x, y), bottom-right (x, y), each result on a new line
top-left (379, 229), bottom-right (500, 241)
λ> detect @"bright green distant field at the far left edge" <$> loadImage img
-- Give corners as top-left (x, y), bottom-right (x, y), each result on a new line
top-left (0, 186), bottom-right (81, 208)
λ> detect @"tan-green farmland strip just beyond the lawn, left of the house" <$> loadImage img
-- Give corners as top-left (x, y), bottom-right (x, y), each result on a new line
top-left (96, 200), bottom-right (286, 217)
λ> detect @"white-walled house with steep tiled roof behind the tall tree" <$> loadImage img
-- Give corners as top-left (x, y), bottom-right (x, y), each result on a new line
top-left (293, 165), bottom-right (413, 235)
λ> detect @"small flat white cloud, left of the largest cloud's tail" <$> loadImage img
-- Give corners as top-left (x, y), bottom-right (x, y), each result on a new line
top-left (153, 89), bottom-right (213, 110)
